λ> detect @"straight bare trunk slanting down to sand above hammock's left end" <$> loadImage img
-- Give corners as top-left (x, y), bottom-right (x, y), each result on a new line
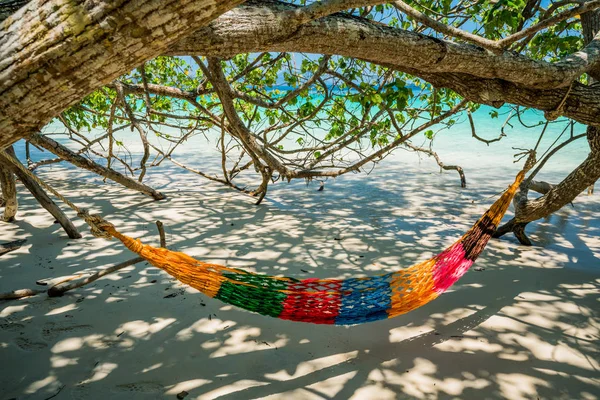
top-left (28, 133), bottom-right (166, 200)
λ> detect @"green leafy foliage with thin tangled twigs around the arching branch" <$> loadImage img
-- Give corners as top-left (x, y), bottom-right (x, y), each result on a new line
top-left (44, 0), bottom-right (583, 195)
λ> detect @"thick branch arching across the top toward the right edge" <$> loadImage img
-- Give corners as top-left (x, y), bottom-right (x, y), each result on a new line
top-left (166, 0), bottom-right (600, 89)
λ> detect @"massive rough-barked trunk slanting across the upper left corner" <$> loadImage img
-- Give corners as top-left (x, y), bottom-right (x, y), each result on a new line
top-left (0, 0), bottom-right (242, 149)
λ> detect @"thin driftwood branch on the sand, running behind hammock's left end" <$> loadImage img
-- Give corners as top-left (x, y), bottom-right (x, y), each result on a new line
top-left (0, 221), bottom-right (167, 300)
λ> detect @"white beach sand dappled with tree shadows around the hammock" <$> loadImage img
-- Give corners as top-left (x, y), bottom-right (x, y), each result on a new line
top-left (0, 151), bottom-right (600, 400)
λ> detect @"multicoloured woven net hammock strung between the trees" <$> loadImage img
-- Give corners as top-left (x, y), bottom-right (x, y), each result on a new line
top-left (3, 153), bottom-right (534, 325)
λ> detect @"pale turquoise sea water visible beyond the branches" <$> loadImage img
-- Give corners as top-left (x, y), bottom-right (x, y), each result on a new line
top-left (15, 101), bottom-right (589, 188)
